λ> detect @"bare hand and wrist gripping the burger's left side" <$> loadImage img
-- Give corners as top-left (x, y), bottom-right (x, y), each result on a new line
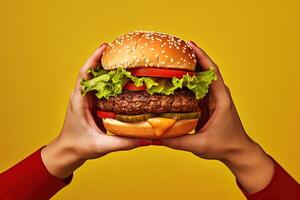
top-left (42, 44), bottom-right (151, 179)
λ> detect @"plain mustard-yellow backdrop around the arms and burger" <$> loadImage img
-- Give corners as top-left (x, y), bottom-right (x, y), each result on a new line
top-left (0, 0), bottom-right (300, 200)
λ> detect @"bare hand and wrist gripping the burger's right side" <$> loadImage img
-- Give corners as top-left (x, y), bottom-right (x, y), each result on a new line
top-left (162, 42), bottom-right (274, 193)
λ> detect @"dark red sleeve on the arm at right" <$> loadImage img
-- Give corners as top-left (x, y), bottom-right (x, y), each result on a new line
top-left (237, 160), bottom-right (300, 200)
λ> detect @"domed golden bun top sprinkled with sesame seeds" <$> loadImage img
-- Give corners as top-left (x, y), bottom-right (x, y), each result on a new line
top-left (101, 31), bottom-right (196, 71)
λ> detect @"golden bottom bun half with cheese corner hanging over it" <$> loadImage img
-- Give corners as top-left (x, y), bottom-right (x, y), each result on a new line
top-left (102, 117), bottom-right (198, 138)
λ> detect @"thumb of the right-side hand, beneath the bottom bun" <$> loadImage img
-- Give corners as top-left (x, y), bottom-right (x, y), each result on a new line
top-left (161, 133), bottom-right (204, 153)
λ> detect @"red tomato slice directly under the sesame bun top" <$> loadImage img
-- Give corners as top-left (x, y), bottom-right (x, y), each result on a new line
top-left (129, 67), bottom-right (195, 78)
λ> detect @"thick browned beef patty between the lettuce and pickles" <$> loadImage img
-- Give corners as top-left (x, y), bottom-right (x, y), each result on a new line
top-left (97, 90), bottom-right (200, 114)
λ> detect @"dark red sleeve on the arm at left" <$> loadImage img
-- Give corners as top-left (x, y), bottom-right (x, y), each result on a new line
top-left (0, 149), bottom-right (72, 200)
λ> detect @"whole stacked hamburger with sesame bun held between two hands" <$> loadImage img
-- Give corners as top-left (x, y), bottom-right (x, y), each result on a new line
top-left (81, 31), bottom-right (216, 139)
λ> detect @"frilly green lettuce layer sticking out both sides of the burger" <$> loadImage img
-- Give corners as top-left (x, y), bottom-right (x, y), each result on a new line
top-left (81, 68), bottom-right (217, 99)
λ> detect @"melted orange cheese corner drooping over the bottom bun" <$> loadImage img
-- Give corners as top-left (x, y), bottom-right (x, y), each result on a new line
top-left (147, 117), bottom-right (176, 137)
